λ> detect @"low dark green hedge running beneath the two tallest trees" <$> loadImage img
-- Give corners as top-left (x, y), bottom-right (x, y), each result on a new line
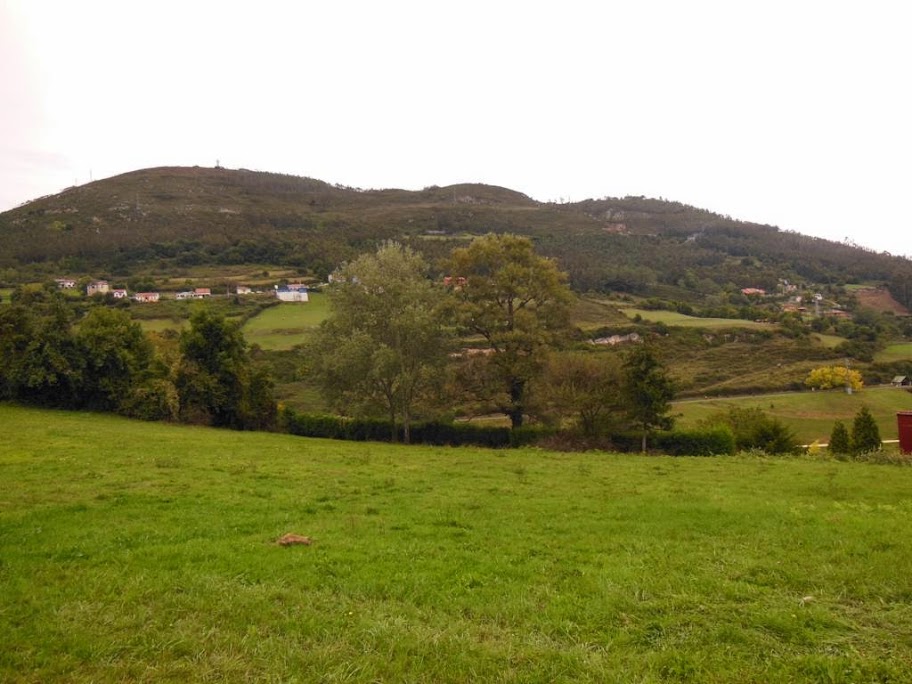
top-left (281, 408), bottom-right (549, 448)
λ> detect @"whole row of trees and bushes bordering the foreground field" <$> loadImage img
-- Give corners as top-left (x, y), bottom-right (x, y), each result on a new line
top-left (0, 234), bottom-right (816, 453)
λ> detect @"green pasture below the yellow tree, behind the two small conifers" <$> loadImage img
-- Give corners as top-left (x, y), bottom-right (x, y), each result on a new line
top-left (673, 387), bottom-right (912, 444)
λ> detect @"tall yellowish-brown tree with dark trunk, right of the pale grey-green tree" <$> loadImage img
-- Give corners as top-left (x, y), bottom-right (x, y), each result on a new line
top-left (449, 234), bottom-right (572, 428)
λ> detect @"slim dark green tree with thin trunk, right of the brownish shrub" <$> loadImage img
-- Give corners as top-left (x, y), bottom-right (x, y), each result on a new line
top-left (624, 345), bottom-right (674, 453)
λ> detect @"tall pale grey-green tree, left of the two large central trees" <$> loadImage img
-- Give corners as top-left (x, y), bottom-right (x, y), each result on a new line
top-left (309, 242), bottom-right (447, 442)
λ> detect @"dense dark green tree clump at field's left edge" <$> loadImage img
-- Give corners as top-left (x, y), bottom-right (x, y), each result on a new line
top-left (0, 288), bottom-right (277, 429)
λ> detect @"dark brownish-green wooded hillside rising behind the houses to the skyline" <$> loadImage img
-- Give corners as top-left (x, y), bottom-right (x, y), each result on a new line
top-left (0, 167), bottom-right (912, 307)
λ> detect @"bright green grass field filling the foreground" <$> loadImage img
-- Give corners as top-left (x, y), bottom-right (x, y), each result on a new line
top-left (0, 405), bottom-right (912, 683)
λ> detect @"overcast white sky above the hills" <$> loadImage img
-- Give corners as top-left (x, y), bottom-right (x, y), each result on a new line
top-left (0, 0), bottom-right (912, 255)
